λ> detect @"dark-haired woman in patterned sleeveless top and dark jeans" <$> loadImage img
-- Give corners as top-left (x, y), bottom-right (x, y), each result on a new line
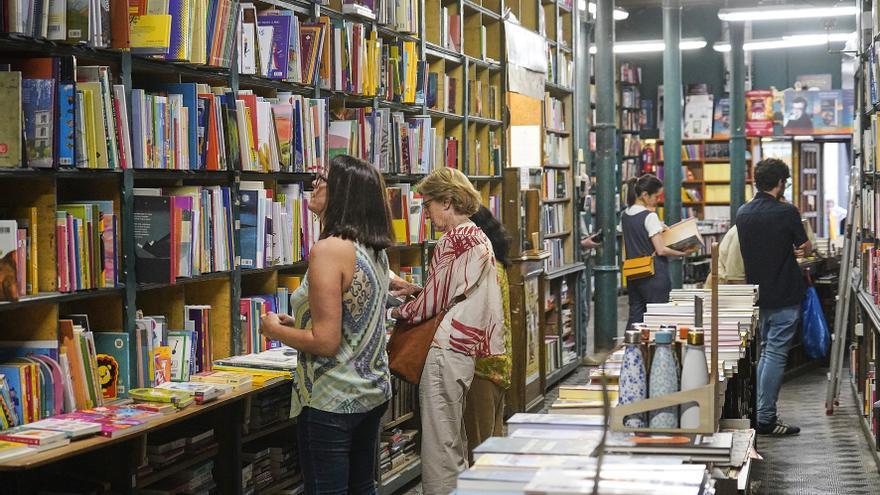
top-left (261, 155), bottom-right (393, 495)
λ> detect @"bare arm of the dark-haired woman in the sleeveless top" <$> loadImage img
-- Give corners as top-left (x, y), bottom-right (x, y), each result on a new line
top-left (260, 237), bottom-right (355, 357)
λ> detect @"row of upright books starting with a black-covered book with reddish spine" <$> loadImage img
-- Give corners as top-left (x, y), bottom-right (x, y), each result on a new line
top-left (134, 186), bottom-right (235, 284)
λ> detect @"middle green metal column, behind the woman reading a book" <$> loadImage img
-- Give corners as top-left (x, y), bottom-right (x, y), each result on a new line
top-left (663, 0), bottom-right (682, 289)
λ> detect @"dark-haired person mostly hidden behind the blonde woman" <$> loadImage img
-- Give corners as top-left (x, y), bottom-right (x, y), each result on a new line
top-left (464, 206), bottom-right (513, 456)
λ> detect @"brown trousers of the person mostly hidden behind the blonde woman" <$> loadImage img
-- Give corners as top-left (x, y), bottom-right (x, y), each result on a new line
top-left (464, 376), bottom-right (505, 462)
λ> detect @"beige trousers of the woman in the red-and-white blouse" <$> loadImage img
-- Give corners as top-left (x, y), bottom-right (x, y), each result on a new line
top-left (419, 347), bottom-right (474, 495)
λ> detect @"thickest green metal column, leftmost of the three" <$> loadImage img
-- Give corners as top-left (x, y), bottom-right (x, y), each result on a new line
top-left (592, 0), bottom-right (618, 352)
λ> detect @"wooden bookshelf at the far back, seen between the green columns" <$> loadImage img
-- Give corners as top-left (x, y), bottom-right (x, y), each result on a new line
top-left (649, 138), bottom-right (759, 221)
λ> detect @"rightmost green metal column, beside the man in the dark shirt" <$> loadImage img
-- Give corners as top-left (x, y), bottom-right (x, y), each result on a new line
top-left (728, 22), bottom-right (746, 219)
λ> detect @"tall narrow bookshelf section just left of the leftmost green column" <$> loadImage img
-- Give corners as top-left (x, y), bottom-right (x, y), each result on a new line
top-left (504, 1), bottom-right (586, 412)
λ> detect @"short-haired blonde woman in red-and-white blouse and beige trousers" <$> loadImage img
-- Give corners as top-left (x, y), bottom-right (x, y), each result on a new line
top-left (391, 167), bottom-right (505, 495)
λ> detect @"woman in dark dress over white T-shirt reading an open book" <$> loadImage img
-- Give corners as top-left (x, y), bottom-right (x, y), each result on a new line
top-left (620, 174), bottom-right (691, 329)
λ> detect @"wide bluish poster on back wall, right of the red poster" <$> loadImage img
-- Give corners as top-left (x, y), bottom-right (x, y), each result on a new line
top-left (783, 89), bottom-right (854, 135)
